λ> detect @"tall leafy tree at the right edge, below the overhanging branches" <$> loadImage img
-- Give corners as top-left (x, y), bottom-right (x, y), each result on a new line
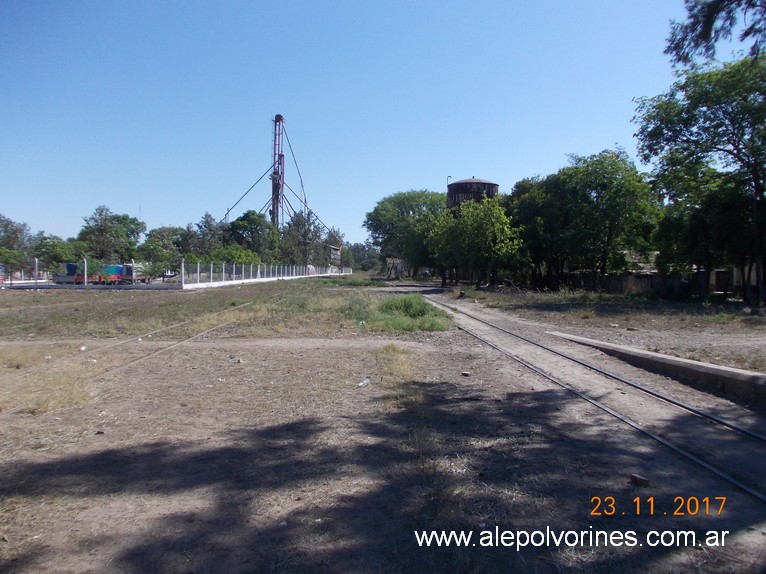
top-left (634, 58), bottom-right (766, 299)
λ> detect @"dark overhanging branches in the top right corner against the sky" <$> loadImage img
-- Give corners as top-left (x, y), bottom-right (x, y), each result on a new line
top-left (665, 0), bottom-right (766, 64)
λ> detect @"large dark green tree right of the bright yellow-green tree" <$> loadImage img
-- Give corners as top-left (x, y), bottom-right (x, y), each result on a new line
top-left (506, 150), bottom-right (660, 289)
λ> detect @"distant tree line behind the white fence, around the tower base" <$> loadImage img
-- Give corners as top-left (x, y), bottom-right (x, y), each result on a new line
top-left (0, 206), bottom-right (377, 284)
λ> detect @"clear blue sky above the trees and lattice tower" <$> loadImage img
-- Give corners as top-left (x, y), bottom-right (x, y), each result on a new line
top-left (0, 0), bottom-right (728, 243)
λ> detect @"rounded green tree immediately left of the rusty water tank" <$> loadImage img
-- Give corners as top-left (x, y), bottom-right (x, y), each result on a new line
top-left (364, 189), bottom-right (447, 275)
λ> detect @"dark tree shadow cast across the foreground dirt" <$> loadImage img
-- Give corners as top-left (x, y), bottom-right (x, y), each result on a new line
top-left (0, 382), bottom-right (766, 574)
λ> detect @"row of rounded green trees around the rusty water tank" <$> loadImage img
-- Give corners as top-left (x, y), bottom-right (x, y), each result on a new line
top-left (364, 150), bottom-right (661, 288)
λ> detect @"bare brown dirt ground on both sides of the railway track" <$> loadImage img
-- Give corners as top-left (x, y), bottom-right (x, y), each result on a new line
top-left (0, 290), bottom-right (766, 573)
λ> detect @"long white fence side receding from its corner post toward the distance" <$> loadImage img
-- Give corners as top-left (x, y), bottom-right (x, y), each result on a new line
top-left (180, 261), bottom-right (352, 289)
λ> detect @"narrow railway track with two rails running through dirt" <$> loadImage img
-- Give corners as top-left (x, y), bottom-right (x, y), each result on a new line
top-left (424, 295), bottom-right (766, 503)
